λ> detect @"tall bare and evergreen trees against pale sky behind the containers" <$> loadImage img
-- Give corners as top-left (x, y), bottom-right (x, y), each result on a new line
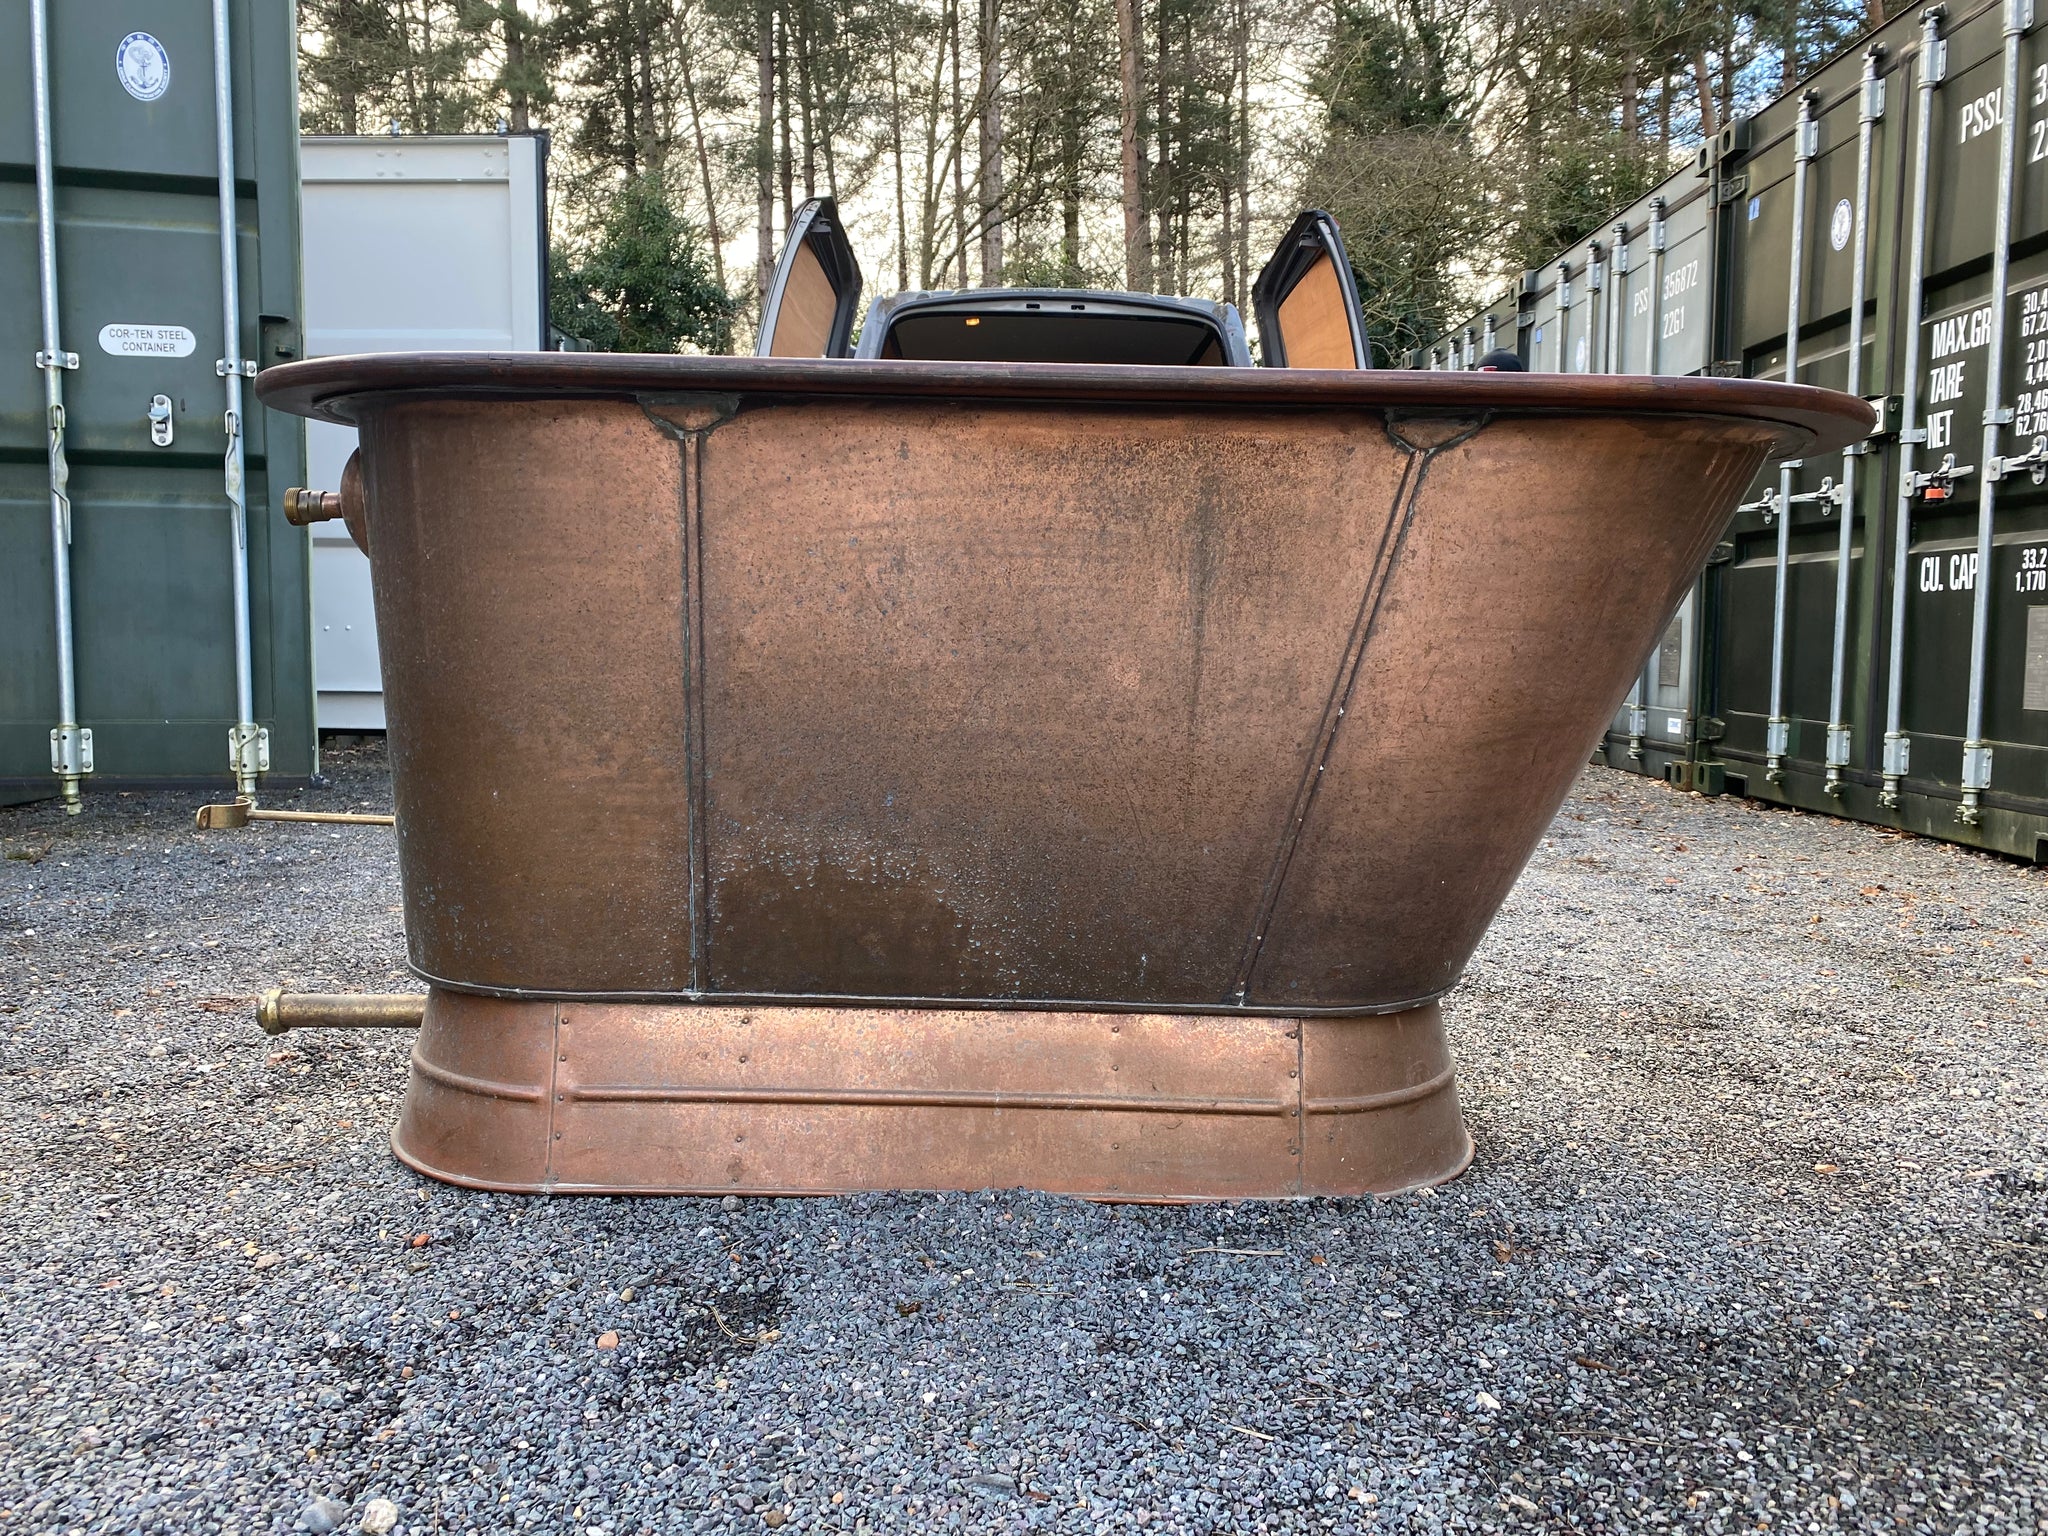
top-left (299, 0), bottom-right (1884, 362)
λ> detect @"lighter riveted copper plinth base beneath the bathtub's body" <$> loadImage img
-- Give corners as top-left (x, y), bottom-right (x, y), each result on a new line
top-left (391, 989), bottom-right (1473, 1200)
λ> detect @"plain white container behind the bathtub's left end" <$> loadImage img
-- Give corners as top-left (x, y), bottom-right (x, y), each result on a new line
top-left (299, 133), bottom-right (547, 731)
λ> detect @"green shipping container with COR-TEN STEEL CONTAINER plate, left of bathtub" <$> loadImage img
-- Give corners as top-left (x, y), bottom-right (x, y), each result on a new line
top-left (0, 0), bottom-right (317, 805)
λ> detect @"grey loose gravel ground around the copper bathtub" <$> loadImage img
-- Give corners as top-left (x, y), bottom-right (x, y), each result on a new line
top-left (0, 750), bottom-right (2048, 1536)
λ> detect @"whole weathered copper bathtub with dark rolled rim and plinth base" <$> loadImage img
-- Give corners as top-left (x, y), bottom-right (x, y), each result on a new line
top-left (258, 354), bottom-right (1872, 1198)
